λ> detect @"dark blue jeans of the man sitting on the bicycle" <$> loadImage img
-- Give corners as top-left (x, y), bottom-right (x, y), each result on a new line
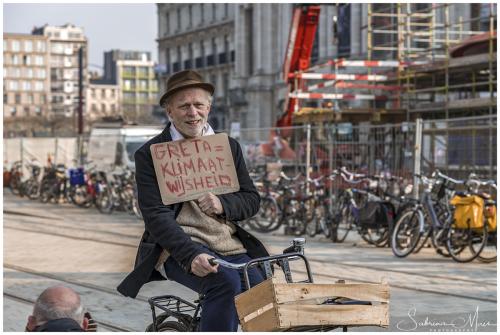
top-left (165, 248), bottom-right (264, 332)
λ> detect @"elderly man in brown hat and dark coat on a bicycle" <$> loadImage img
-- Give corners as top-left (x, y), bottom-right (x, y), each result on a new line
top-left (118, 70), bottom-right (268, 331)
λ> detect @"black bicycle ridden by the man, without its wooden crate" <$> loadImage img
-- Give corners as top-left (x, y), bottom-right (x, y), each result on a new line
top-left (146, 238), bottom-right (371, 332)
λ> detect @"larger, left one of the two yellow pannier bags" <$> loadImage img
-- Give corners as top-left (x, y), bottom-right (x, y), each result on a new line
top-left (450, 195), bottom-right (484, 229)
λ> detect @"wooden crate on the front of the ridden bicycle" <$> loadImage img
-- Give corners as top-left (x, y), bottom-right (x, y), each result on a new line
top-left (235, 277), bottom-right (389, 331)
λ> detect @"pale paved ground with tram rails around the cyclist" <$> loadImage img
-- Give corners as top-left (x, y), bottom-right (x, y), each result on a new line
top-left (3, 189), bottom-right (497, 331)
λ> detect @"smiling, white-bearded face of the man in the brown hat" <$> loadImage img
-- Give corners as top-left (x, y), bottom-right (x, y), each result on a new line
top-left (167, 88), bottom-right (210, 138)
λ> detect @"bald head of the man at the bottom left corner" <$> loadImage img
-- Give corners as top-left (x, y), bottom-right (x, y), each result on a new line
top-left (33, 286), bottom-right (84, 325)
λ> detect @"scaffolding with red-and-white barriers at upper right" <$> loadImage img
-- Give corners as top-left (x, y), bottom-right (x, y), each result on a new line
top-left (290, 3), bottom-right (497, 124)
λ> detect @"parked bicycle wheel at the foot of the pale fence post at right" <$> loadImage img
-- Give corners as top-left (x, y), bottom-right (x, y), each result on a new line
top-left (391, 209), bottom-right (423, 257)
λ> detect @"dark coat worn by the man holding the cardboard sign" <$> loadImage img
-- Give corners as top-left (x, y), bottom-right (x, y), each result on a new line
top-left (117, 123), bottom-right (269, 298)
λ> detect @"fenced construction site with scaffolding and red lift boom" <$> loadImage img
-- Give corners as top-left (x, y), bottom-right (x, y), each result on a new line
top-left (242, 3), bottom-right (497, 181)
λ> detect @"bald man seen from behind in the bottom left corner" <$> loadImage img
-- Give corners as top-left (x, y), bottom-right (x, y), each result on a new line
top-left (26, 286), bottom-right (89, 332)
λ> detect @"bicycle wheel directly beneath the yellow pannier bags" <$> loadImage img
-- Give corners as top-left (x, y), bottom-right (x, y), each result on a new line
top-left (446, 225), bottom-right (488, 263)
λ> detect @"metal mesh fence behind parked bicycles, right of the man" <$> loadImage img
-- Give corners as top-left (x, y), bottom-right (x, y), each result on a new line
top-left (238, 115), bottom-right (497, 184)
